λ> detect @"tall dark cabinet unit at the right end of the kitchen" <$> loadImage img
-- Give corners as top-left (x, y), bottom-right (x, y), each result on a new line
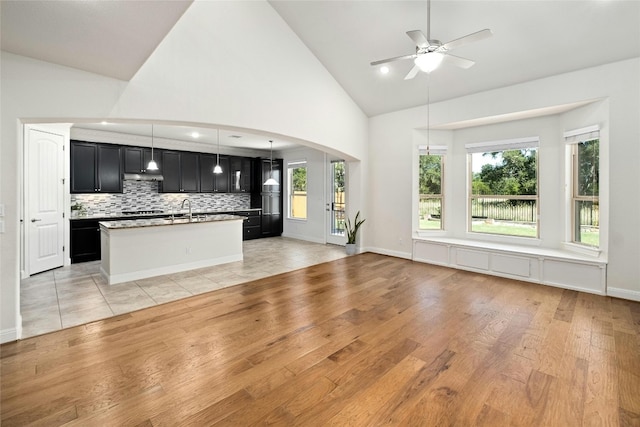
top-left (251, 159), bottom-right (283, 237)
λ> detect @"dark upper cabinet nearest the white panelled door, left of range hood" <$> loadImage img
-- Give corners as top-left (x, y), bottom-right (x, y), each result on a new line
top-left (70, 141), bottom-right (122, 193)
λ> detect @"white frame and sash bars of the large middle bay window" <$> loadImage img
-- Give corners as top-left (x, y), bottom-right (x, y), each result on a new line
top-left (465, 136), bottom-right (540, 241)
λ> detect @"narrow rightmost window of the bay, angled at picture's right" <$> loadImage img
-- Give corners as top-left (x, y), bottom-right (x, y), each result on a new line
top-left (565, 126), bottom-right (600, 247)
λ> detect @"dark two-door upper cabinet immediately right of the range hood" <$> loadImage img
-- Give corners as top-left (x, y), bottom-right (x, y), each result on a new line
top-left (160, 150), bottom-right (200, 193)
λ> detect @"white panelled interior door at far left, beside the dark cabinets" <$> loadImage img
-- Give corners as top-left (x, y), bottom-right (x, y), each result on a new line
top-left (25, 128), bottom-right (64, 274)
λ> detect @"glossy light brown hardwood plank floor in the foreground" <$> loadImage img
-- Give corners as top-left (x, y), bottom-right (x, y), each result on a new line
top-left (0, 253), bottom-right (640, 426)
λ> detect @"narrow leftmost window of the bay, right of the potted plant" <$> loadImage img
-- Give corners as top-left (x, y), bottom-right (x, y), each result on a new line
top-left (418, 146), bottom-right (446, 230)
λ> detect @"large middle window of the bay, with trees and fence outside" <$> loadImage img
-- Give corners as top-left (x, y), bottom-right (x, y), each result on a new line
top-left (466, 138), bottom-right (539, 238)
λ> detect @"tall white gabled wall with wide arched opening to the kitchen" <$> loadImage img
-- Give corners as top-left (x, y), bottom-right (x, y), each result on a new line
top-left (0, 2), bottom-right (367, 342)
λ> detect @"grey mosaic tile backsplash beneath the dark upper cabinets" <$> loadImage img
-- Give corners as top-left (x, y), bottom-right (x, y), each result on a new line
top-left (71, 181), bottom-right (251, 215)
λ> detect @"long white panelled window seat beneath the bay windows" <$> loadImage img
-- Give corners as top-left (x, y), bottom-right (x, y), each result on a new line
top-left (413, 237), bottom-right (607, 295)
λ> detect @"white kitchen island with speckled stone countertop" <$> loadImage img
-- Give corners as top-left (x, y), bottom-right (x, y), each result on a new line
top-left (99, 215), bottom-right (245, 285)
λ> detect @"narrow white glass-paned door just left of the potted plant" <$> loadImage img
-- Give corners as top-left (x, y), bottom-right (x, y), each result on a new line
top-left (326, 160), bottom-right (347, 246)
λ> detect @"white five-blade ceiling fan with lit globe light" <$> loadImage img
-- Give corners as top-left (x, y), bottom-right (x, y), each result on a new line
top-left (371, 0), bottom-right (492, 80)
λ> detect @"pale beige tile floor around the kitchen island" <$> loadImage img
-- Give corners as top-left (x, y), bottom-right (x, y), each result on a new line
top-left (20, 237), bottom-right (346, 338)
